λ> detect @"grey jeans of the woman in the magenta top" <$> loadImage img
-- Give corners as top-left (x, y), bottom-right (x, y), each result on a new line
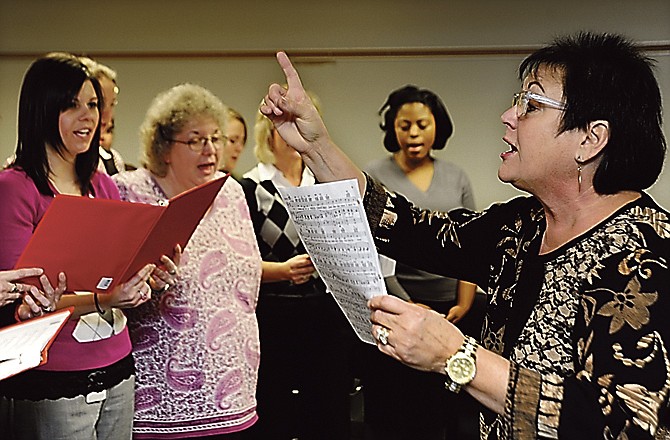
top-left (0, 376), bottom-right (135, 440)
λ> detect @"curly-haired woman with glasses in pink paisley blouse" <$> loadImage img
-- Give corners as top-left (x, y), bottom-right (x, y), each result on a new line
top-left (114, 84), bottom-right (261, 439)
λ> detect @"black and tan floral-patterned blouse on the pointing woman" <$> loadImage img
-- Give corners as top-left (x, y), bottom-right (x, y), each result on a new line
top-left (365, 179), bottom-right (670, 440)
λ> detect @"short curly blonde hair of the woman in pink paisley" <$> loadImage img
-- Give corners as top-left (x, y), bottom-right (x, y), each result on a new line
top-left (140, 83), bottom-right (228, 177)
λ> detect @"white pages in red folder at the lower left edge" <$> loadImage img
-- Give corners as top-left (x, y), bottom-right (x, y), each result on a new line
top-left (0, 307), bottom-right (74, 380)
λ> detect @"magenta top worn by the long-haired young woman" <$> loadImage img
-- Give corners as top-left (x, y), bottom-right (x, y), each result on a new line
top-left (0, 169), bottom-right (131, 371)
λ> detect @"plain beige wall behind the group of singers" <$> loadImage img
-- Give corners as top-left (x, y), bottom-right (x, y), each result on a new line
top-left (0, 0), bottom-right (670, 208)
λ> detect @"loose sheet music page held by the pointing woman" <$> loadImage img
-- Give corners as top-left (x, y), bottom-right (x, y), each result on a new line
top-left (278, 180), bottom-right (386, 344)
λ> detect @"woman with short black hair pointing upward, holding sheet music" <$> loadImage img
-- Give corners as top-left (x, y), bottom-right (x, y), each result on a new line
top-left (260, 32), bottom-right (670, 440)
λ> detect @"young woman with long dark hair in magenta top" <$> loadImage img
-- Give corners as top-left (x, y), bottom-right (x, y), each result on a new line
top-left (0, 53), bottom-right (178, 440)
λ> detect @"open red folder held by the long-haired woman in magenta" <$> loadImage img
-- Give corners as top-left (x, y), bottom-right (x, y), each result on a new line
top-left (16, 175), bottom-right (228, 293)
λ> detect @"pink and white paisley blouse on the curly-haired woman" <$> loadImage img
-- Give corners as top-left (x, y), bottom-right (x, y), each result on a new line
top-left (115, 170), bottom-right (261, 439)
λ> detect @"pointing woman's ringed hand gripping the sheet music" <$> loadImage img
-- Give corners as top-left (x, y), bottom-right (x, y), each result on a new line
top-left (368, 295), bottom-right (463, 373)
